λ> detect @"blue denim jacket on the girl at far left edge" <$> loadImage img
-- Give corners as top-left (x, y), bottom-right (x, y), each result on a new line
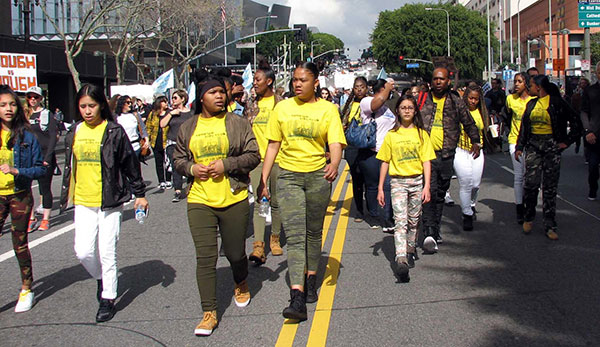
top-left (13, 130), bottom-right (46, 192)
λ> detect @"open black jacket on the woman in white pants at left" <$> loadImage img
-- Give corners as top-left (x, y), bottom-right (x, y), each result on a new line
top-left (60, 121), bottom-right (146, 212)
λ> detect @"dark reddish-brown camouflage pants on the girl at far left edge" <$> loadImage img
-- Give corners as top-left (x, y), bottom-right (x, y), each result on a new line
top-left (0, 189), bottom-right (33, 285)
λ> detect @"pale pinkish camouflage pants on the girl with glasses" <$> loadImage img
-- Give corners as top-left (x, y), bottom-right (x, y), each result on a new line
top-left (391, 175), bottom-right (423, 259)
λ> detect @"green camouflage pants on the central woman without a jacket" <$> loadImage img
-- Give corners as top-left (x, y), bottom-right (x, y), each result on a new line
top-left (277, 169), bottom-right (331, 286)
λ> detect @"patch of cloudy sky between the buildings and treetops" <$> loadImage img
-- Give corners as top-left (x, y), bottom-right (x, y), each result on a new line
top-left (254, 0), bottom-right (435, 59)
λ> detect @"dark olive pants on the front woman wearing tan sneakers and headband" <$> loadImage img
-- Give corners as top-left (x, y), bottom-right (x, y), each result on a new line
top-left (188, 200), bottom-right (250, 312)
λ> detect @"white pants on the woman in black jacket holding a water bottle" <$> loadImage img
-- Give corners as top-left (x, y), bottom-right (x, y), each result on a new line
top-left (75, 205), bottom-right (123, 299)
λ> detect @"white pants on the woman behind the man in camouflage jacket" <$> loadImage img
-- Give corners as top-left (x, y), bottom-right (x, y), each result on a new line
top-left (454, 148), bottom-right (484, 216)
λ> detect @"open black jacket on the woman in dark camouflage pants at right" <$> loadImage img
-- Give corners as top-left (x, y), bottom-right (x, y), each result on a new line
top-left (515, 95), bottom-right (582, 151)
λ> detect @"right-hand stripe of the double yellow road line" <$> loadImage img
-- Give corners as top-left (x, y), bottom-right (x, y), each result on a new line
top-left (306, 181), bottom-right (353, 347)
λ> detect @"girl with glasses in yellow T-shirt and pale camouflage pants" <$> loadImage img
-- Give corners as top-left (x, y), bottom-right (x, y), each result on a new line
top-left (377, 95), bottom-right (435, 282)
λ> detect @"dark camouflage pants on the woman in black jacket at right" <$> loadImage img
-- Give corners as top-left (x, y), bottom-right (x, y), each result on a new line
top-left (523, 135), bottom-right (560, 228)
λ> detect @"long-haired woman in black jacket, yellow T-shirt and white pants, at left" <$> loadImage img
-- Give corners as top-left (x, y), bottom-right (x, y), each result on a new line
top-left (60, 84), bottom-right (148, 322)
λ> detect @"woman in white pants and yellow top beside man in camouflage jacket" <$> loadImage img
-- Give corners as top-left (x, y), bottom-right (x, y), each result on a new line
top-left (453, 85), bottom-right (490, 231)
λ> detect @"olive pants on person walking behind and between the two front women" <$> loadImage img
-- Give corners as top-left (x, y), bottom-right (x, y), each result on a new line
top-left (250, 162), bottom-right (281, 241)
